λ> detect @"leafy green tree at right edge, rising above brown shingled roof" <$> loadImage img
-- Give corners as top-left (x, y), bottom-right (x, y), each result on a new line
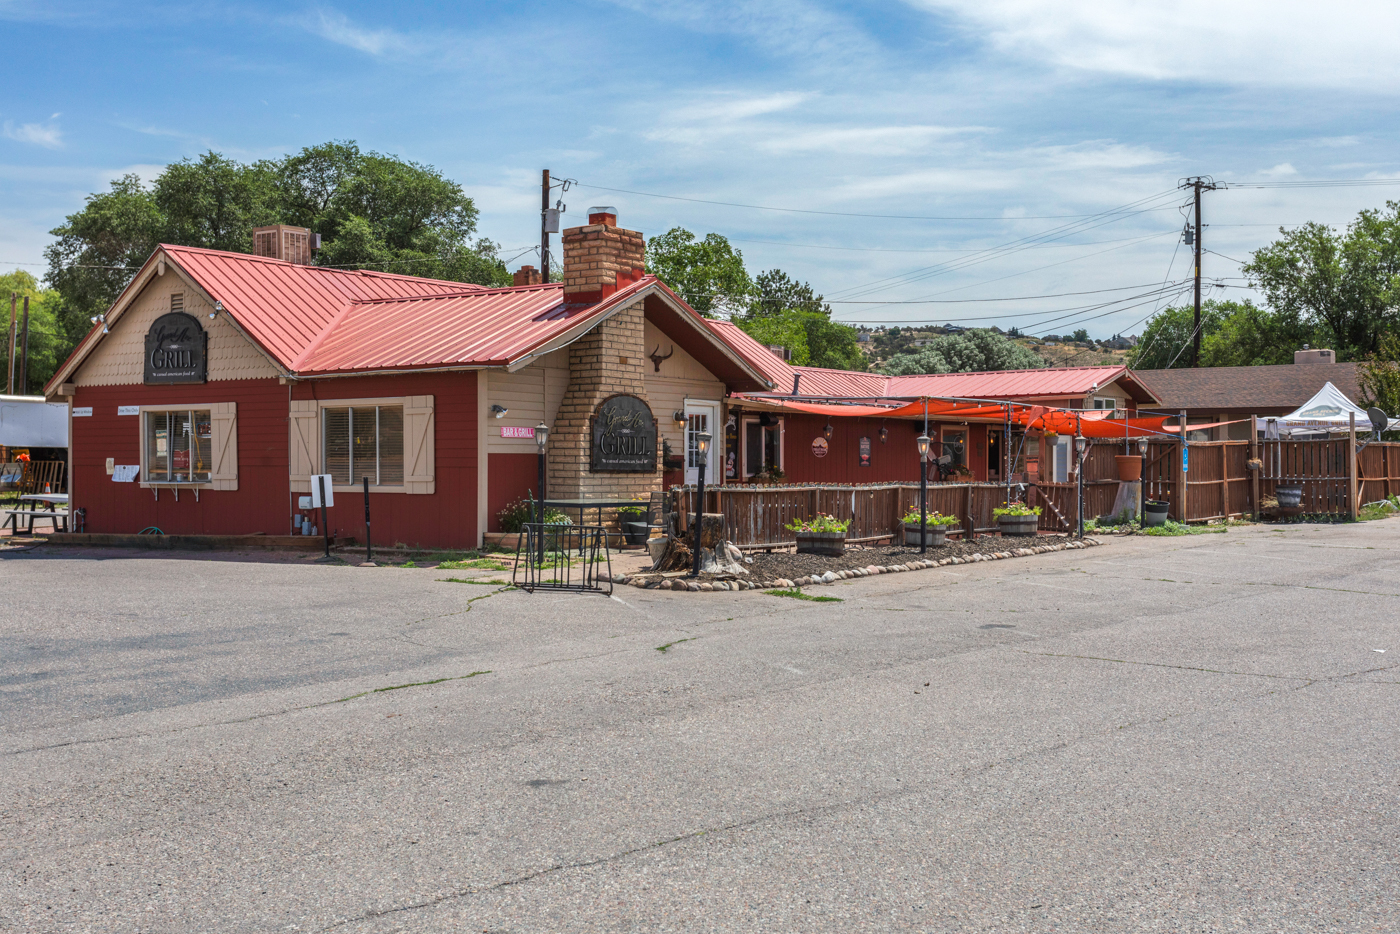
top-left (1245, 202), bottom-right (1400, 360)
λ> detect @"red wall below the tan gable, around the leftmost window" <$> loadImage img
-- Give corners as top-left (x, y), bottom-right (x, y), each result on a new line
top-left (71, 379), bottom-right (290, 535)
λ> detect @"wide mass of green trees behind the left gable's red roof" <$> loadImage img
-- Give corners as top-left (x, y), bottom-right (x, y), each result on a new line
top-left (45, 141), bottom-right (511, 354)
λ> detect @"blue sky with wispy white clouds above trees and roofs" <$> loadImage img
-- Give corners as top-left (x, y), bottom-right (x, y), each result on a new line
top-left (0, 0), bottom-right (1400, 336)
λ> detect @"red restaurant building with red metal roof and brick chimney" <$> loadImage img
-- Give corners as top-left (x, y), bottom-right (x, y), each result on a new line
top-left (45, 209), bottom-right (1152, 548)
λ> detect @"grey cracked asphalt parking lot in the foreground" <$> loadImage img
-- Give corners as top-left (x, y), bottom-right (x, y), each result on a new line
top-left (0, 520), bottom-right (1400, 934)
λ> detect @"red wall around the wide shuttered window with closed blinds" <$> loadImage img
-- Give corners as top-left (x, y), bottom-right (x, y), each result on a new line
top-left (291, 371), bottom-right (479, 548)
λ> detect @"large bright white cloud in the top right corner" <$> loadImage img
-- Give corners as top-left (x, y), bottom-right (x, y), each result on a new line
top-left (907, 0), bottom-right (1400, 91)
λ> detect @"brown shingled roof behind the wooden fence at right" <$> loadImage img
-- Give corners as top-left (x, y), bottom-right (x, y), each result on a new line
top-left (1133, 363), bottom-right (1361, 414)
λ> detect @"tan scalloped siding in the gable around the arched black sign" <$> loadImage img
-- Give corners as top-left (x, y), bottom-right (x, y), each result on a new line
top-left (73, 274), bottom-right (279, 386)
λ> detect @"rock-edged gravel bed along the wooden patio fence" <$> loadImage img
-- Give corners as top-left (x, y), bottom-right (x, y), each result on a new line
top-left (613, 535), bottom-right (1098, 592)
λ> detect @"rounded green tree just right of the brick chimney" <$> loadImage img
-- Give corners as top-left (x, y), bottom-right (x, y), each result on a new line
top-left (647, 227), bottom-right (753, 318)
